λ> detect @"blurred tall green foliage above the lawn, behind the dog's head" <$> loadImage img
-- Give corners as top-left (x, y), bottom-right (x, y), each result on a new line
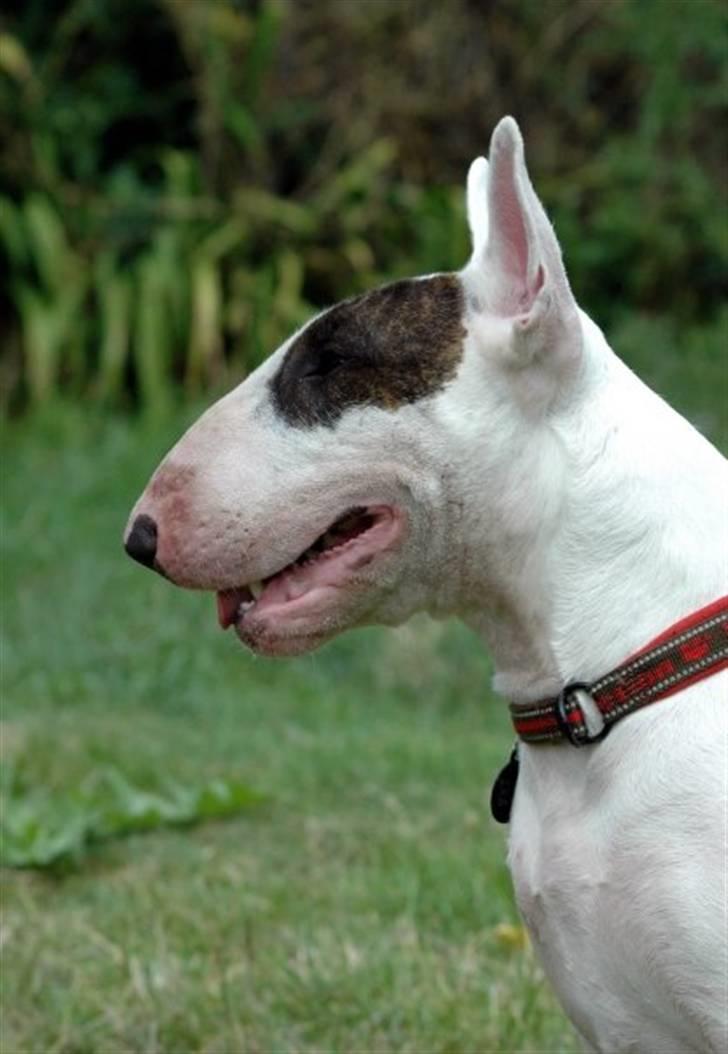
top-left (0, 0), bottom-right (728, 409)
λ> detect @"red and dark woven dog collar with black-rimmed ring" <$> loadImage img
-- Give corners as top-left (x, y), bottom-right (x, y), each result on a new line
top-left (510, 597), bottom-right (728, 746)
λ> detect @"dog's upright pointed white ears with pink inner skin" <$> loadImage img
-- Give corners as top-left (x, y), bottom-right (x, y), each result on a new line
top-left (468, 117), bottom-right (582, 373)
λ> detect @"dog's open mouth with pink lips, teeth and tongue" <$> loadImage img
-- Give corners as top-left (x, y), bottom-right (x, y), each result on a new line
top-left (217, 505), bottom-right (401, 629)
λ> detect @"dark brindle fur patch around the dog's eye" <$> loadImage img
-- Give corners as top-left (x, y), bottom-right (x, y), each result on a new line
top-left (272, 274), bottom-right (465, 426)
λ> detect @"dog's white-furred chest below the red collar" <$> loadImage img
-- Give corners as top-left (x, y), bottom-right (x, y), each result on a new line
top-left (509, 716), bottom-right (726, 1054)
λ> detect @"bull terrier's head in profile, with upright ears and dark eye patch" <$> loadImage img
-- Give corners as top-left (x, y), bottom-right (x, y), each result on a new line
top-left (125, 118), bottom-right (582, 655)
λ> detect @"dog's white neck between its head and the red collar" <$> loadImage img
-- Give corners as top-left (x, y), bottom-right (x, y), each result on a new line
top-left (465, 316), bottom-right (728, 702)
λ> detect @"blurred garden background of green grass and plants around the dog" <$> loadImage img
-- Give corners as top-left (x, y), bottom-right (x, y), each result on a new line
top-left (0, 0), bottom-right (728, 1054)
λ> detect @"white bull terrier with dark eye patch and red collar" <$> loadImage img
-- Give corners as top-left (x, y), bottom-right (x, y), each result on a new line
top-left (126, 117), bottom-right (728, 1054)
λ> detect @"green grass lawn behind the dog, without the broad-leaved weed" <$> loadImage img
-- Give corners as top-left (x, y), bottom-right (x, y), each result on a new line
top-left (0, 330), bottom-right (725, 1054)
